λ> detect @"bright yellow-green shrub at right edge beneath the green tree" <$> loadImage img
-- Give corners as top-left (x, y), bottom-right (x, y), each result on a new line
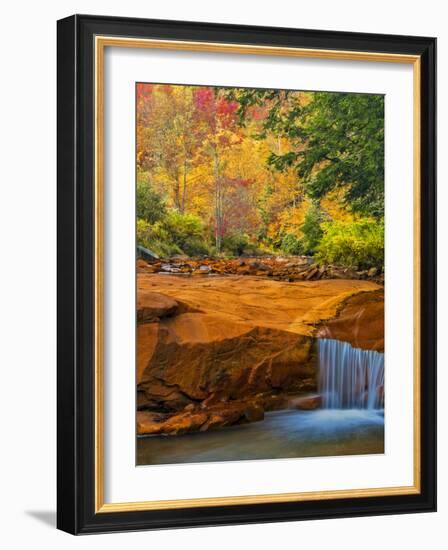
top-left (315, 218), bottom-right (384, 269)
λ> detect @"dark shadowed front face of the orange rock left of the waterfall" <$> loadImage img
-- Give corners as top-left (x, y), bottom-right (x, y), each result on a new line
top-left (138, 313), bottom-right (315, 411)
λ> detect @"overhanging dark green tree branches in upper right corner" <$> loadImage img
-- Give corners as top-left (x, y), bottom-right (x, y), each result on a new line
top-left (231, 89), bottom-right (384, 218)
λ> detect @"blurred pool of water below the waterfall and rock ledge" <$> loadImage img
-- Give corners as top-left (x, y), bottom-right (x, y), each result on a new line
top-left (137, 409), bottom-right (384, 465)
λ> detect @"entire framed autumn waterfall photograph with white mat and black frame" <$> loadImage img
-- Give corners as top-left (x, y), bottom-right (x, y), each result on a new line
top-left (57, 15), bottom-right (436, 534)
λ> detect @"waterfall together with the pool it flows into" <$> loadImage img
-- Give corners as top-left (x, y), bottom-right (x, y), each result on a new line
top-left (137, 340), bottom-right (384, 465)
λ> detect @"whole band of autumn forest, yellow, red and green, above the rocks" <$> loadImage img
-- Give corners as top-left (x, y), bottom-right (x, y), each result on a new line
top-left (136, 83), bottom-right (384, 267)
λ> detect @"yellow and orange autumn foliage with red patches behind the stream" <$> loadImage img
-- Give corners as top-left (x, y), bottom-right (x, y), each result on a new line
top-left (136, 85), bottom-right (360, 254)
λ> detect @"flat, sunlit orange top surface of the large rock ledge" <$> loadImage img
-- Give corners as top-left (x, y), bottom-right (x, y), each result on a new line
top-left (137, 273), bottom-right (382, 336)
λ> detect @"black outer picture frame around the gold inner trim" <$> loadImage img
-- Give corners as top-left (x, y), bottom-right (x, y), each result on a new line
top-left (57, 15), bottom-right (436, 534)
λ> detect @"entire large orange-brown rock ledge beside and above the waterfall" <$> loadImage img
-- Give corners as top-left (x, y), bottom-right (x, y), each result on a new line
top-left (137, 272), bottom-right (381, 435)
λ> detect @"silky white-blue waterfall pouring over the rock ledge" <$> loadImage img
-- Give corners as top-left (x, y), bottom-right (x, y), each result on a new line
top-left (318, 339), bottom-right (384, 409)
